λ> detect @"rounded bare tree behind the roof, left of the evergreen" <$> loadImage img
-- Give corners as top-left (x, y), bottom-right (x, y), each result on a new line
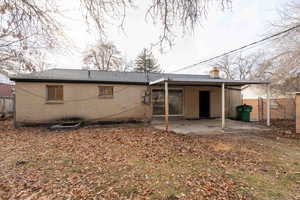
top-left (83, 42), bottom-right (123, 71)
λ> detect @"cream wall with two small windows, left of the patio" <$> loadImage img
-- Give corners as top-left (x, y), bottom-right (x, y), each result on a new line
top-left (16, 82), bottom-right (151, 123)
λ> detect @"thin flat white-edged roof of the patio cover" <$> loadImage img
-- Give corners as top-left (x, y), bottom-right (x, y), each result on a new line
top-left (150, 77), bottom-right (270, 86)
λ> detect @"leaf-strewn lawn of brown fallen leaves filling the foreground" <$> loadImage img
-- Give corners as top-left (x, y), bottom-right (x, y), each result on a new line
top-left (0, 121), bottom-right (300, 200)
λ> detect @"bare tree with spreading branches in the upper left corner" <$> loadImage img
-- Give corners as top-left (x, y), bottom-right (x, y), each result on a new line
top-left (0, 0), bottom-right (63, 72)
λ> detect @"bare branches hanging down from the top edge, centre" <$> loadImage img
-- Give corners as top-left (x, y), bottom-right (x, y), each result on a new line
top-left (81, 0), bottom-right (231, 46)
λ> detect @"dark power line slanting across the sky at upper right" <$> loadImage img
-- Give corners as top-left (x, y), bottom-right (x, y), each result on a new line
top-left (172, 24), bottom-right (300, 72)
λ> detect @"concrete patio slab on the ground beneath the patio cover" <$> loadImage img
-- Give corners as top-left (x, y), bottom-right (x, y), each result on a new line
top-left (151, 119), bottom-right (270, 135)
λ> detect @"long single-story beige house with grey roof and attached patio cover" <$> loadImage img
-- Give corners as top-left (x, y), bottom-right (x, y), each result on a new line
top-left (10, 68), bottom-right (269, 127)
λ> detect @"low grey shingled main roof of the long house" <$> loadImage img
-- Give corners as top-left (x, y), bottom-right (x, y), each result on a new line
top-left (10, 69), bottom-right (268, 84)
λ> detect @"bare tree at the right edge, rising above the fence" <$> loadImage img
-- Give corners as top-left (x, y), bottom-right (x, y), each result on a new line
top-left (260, 1), bottom-right (300, 95)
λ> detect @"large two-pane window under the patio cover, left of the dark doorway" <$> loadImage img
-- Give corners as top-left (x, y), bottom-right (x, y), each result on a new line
top-left (152, 89), bottom-right (183, 115)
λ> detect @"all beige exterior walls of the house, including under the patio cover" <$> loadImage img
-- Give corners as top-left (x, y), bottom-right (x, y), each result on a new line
top-left (16, 82), bottom-right (241, 123)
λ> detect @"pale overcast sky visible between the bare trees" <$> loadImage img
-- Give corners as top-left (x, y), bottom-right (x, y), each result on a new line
top-left (49, 0), bottom-right (289, 73)
